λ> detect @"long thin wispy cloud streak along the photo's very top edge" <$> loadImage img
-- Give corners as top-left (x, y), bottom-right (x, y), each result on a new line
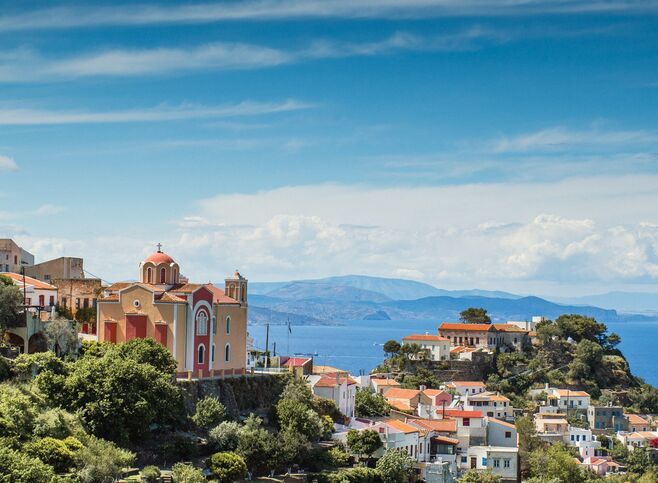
top-left (0, 0), bottom-right (658, 32)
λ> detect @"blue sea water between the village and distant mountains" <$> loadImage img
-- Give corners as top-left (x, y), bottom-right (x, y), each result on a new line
top-left (248, 319), bottom-right (658, 387)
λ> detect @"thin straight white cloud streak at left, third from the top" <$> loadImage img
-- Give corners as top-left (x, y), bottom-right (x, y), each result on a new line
top-left (0, 99), bottom-right (313, 126)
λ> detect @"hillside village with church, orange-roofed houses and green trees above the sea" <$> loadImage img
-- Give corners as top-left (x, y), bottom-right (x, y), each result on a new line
top-left (0, 240), bottom-right (658, 483)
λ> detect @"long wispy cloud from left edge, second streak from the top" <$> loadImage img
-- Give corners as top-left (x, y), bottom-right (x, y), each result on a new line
top-left (0, 30), bottom-right (498, 82)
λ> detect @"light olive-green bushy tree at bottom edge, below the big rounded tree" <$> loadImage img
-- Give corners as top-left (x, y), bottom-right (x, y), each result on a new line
top-left (76, 436), bottom-right (135, 483)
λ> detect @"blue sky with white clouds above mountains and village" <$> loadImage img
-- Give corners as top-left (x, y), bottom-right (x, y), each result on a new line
top-left (0, 0), bottom-right (658, 296)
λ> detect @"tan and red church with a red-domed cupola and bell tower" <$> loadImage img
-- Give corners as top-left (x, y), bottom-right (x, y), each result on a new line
top-left (96, 248), bottom-right (247, 378)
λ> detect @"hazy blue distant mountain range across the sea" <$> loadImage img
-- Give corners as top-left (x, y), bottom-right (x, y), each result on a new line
top-left (240, 275), bottom-right (644, 325)
